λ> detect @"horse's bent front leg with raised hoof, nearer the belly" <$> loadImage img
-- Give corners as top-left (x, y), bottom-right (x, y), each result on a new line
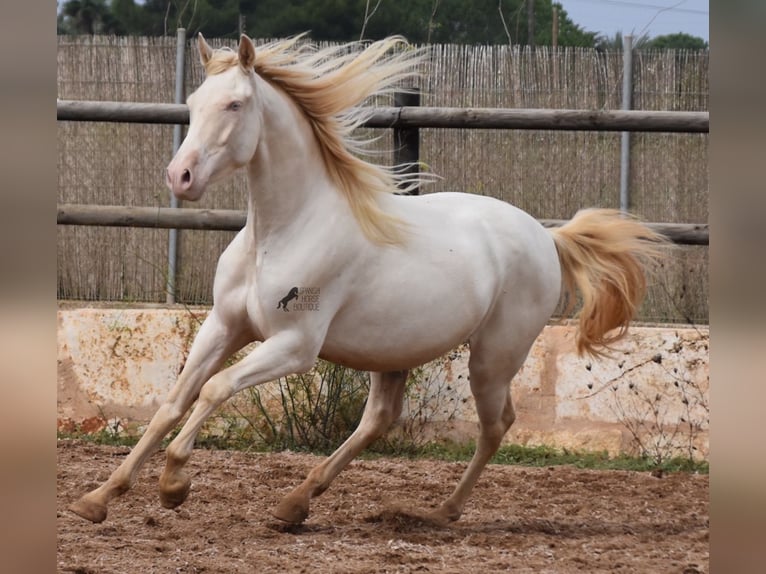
top-left (160, 331), bottom-right (319, 508)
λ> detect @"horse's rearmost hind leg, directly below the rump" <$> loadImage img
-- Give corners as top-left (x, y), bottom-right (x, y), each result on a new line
top-left (431, 346), bottom-right (527, 522)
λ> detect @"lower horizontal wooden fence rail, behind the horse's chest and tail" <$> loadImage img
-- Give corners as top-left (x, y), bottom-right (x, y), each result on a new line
top-left (57, 203), bottom-right (710, 245)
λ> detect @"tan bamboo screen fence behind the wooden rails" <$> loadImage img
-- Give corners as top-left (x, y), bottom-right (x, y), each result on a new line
top-left (58, 36), bottom-right (709, 323)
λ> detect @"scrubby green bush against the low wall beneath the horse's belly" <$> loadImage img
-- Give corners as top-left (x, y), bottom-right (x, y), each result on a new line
top-left (231, 358), bottom-right (459, 455)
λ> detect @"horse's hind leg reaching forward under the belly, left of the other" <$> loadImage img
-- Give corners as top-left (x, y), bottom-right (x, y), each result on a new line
top-left (273, 371), bottom-right (407, 524)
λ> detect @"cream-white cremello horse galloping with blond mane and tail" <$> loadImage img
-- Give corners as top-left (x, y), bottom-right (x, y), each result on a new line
top-left (71, 32), bottom-right (662, 523)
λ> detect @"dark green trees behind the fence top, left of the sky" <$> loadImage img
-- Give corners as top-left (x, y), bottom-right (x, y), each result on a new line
top-left (58, 0), bottom-right (597, 46)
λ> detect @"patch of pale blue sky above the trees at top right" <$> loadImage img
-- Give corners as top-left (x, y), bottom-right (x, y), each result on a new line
top-left (557, 0), bottom-right (710, 42)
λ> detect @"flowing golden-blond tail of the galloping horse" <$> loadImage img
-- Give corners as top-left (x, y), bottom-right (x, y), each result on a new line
top-left (551, 209), bottom-right (667, 356)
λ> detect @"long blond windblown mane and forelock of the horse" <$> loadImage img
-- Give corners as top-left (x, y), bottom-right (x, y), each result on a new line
top-left (205, 36), bottom-right (423, 244)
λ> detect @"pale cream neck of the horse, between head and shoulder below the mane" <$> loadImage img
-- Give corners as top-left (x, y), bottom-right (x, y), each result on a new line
top-left (248, 78), bottom-right (341, 241)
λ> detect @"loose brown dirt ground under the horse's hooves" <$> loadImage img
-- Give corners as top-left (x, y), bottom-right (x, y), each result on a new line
top-left (56, 440), bottom-right (709, 574)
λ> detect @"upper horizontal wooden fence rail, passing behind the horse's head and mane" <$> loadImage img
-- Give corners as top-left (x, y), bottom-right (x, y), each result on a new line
top-left (56, 100), bottom-right (710, 133)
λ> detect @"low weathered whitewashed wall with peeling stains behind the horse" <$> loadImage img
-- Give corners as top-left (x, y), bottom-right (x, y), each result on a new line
top-left (58, 306), bottom-right (709, 459)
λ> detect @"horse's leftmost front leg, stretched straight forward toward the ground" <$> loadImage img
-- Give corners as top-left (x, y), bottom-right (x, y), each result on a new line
top-left (69, 309), bottom-right (250, 522)
